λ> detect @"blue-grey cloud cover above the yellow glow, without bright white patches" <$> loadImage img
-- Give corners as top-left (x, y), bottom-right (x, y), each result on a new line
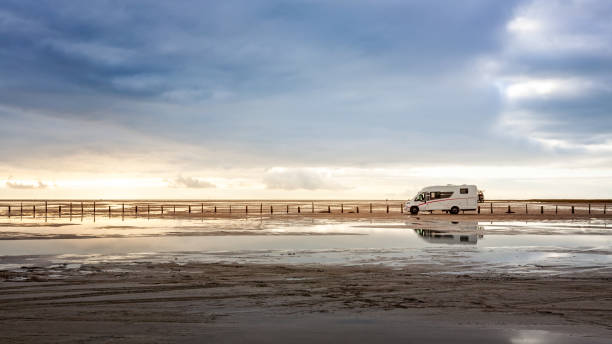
top-left (0, 1), bottom-right (610, 171)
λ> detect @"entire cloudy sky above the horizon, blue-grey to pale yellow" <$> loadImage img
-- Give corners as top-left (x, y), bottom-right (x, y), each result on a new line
top-left (0, 0), bottom-right (612, 199)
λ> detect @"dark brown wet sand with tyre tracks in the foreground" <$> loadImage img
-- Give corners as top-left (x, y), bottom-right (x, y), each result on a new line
top-left (0, 263), bottom-right (612, 343)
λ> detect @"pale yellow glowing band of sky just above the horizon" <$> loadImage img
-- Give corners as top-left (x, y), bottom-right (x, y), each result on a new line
top-left (0, 165), bottom-right (612, 199)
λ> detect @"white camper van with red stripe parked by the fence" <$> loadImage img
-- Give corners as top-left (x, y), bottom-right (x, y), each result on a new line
top-left (404, 184), bottom-right (478, 214)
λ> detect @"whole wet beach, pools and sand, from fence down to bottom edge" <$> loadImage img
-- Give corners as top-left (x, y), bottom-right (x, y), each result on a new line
top-left (0, 213), bottom-right (612, 343)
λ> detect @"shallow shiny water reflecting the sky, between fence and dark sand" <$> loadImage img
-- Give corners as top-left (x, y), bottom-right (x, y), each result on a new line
top-left (0, 217), bottom-right (612, 273)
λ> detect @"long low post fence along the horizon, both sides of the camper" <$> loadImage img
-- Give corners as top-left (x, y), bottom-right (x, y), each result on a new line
top-left (0, 200), bottom-right (612, 217)
